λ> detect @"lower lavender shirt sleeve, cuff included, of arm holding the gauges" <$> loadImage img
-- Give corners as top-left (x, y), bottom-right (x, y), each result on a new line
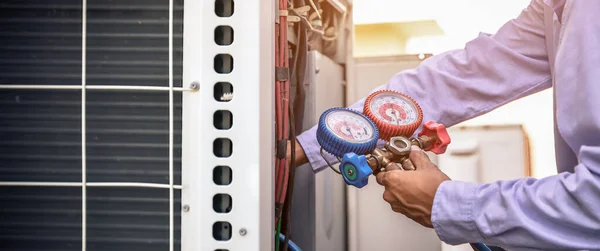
top-left (431, 145), bottom-right (600, 250)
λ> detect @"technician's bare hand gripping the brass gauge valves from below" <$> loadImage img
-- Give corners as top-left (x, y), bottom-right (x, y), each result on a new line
top-left (377, 146), bottom-right (450, 228)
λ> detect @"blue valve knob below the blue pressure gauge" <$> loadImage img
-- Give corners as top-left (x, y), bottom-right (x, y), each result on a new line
top-left (340, 152), bottom-right (373, 188)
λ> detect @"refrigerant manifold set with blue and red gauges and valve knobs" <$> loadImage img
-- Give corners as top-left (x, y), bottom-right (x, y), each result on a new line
top-left (317, 90), bottom-right (450, 188)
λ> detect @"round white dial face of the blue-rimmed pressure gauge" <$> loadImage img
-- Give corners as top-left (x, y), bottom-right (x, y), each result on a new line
top-left (325, 110), bottom-right (374, 143)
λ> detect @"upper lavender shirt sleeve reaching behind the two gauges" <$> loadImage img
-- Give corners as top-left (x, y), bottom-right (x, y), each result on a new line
top-left (297, 0), bottom-right (551, 172)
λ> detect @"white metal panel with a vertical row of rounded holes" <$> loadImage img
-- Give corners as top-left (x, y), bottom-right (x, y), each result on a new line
top-left (182, 0), bottom-right (274, 251)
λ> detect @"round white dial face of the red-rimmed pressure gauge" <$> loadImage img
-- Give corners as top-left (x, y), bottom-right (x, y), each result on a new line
top-left (370, 93), bottom-right (419, 125)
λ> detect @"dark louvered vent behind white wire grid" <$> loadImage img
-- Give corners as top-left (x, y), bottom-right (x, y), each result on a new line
top-left (0, 0), bottom-right (186, 251)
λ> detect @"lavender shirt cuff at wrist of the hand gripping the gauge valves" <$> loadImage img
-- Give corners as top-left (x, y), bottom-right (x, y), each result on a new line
top-left (431, 180), bottom-right (484, 245)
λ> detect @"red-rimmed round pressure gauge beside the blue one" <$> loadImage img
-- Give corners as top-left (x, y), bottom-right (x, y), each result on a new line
top-left (363, 90), bottom-right (423, 141)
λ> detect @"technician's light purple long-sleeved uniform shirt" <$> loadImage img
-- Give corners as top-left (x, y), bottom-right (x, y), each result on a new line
top-left (298, 0), bottom-right (600, 250)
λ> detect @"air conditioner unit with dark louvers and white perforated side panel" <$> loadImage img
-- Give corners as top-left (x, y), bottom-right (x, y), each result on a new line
top-left (0, 0), bottom-right (275, 251)
